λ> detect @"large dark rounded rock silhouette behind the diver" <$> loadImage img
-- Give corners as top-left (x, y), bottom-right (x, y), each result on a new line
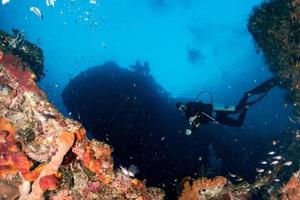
top-left (62, 62), bottom-right (197, 197)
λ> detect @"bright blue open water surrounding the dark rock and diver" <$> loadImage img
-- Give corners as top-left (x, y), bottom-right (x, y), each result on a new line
top-left (0, 0), bottom-right (291, 198)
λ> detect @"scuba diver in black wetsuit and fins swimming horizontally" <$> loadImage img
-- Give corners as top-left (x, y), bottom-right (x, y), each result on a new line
top-left (176, 76), bottom-right (279, 135)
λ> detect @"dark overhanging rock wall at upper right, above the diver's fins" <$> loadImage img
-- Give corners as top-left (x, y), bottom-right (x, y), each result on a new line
top-left (248, 0), bottom-right (300, 122)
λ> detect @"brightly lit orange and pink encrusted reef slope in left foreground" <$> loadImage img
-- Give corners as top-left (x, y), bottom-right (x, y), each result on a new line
top-left (0, 51), bottom-right (164, 200)
